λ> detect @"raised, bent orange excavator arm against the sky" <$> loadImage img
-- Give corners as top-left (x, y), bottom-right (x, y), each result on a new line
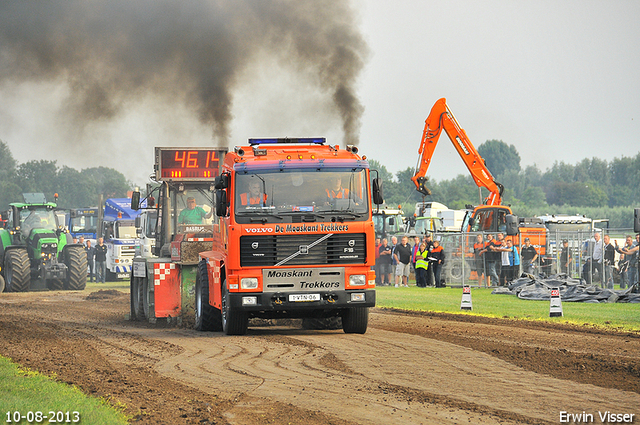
top-left (411, 98), bottom-right (504, 205)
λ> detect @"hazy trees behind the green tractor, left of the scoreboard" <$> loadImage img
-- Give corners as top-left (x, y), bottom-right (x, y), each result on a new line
top-left (0, 140), bottom-right (133, 211)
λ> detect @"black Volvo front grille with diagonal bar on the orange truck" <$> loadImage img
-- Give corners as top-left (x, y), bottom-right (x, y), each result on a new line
top-left (240, 233), bottom-right (366, 267)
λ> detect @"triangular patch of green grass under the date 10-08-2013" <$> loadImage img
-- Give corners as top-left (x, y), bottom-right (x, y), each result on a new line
top-left (0, 356), bottom-right (128, 425)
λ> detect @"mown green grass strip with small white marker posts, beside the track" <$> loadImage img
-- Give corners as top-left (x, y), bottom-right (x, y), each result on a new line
top-left (376, 286), bottom-right (640, 332)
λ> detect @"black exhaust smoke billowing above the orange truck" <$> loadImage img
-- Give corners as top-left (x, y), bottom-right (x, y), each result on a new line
top-left (0, 0), bottom-right (368, 144)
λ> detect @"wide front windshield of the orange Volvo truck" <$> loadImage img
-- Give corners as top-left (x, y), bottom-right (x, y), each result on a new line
top-left (234, 169), bottom-right (369, 219)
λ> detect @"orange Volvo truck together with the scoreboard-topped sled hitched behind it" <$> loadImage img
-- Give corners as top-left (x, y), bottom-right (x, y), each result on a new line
top-left (131, 138), bottom-right (382, 335)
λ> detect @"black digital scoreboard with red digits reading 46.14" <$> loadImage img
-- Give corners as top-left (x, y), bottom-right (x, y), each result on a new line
top-left (155, 148), bottom-right (227, 181)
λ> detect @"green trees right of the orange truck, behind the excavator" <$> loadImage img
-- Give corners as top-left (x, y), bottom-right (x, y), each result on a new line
top-left (369, 140), bottom-right (640, 228)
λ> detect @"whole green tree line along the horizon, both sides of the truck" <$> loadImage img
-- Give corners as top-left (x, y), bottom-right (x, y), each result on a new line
top-left (0, 140), bottom-right (640, 228)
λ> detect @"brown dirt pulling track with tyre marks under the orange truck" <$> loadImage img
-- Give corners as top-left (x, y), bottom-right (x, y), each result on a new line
top-left (0, 290), bottom-right (640, 424)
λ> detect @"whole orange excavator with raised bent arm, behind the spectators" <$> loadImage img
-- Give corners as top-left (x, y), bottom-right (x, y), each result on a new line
top-left (411, 98), bottom-right (548, 276)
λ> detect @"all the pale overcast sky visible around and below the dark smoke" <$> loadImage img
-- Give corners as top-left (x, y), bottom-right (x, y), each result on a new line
top-left (0, 0), bottom-right (640, 184)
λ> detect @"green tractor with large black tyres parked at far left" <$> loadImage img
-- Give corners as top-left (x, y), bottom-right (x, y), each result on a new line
top-left (0, 193), bottom-right (87, 292)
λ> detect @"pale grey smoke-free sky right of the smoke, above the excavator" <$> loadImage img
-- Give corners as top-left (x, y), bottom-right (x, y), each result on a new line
top-left (360, 0), bottom-right (640, 184)
